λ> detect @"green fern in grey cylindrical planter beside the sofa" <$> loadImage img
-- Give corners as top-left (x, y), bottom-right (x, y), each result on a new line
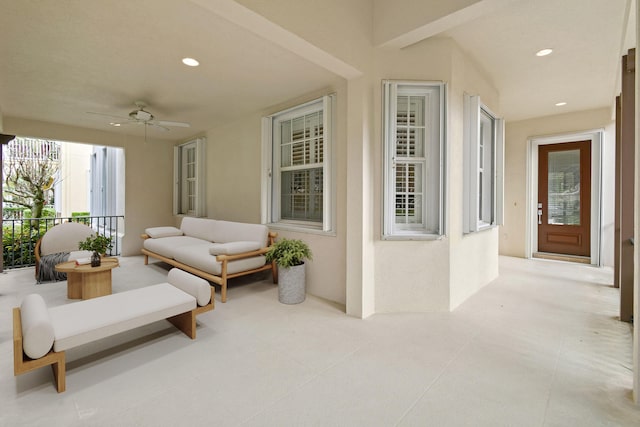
top-left (265, 238), bottom-right (312, 304)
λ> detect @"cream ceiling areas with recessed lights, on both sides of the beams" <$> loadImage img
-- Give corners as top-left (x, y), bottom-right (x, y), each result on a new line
top-left (0, 0), bottom-right (635, 140)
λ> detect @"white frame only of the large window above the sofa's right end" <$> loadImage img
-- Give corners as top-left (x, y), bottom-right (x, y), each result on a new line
top-left (261, 94), bottom-right (336, 235)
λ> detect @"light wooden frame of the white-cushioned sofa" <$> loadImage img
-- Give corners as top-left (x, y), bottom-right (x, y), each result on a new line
top-left (140, 231), bottom-right (278, 302)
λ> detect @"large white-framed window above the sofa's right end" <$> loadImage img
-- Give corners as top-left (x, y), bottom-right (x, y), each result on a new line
top-left (263, 95), bottom-right (335, 232)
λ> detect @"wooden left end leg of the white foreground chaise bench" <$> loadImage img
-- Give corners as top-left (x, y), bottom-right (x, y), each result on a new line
top-left (13, 307), bottom-right (66, 393)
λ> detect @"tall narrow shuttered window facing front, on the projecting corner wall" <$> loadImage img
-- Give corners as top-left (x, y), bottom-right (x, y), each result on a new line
top-left (383, 81), bottom-right (445, 239)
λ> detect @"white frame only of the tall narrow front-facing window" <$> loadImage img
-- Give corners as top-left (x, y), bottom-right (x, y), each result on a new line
top-left (382, 80), bottom-right (447, 240)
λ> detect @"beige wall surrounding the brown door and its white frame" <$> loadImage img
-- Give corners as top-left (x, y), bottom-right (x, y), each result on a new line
top-left (500, 108), bottom-right (615, 266)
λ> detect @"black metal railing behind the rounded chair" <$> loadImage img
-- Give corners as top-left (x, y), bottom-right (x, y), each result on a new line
top-left (2, 215), bottom-right (124, 269)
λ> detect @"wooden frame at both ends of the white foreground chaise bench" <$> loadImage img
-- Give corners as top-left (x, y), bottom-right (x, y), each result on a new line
top-left (13, 288), bottom-right (215, 393)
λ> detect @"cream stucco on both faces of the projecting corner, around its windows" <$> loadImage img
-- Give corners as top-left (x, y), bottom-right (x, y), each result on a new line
top-left (374, 39), bottom-right (498, 312)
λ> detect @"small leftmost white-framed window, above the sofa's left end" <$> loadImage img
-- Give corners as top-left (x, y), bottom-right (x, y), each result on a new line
top-left (173, 138), bottom-right (205, 217)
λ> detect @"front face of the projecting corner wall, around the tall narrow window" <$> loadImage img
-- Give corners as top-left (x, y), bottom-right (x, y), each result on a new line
top-left (371, 39), bottom-right (454, 313)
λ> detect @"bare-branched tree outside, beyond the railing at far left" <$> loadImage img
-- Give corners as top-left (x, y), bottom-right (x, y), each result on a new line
top-left (2, 137), bottom-right (60, 227)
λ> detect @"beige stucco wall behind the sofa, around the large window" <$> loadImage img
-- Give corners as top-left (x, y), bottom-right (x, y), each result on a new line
top-left (201, 79), bottom-right (347, 304)
